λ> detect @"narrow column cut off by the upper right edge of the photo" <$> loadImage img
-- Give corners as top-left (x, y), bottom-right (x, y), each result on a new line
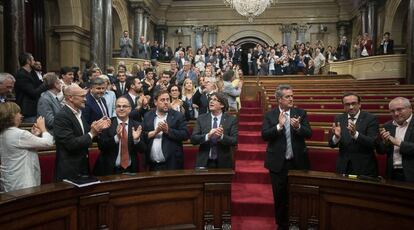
top-left (407, 0), bottom-right (414, 84)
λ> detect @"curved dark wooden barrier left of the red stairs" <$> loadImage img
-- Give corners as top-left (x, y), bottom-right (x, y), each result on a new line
top-left (0, 169), bottom-right (234, 230)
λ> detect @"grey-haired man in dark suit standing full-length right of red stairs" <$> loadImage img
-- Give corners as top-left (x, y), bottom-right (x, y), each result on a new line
top-left (262, 84), bottom-right (312, 229)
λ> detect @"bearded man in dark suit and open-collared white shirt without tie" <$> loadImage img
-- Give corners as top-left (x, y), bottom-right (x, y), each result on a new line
top-left (142, 90), bottom-right (189, 171)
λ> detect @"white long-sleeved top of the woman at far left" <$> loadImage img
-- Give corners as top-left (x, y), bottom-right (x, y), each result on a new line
top-left (0, 127), bottom-right (53, 192)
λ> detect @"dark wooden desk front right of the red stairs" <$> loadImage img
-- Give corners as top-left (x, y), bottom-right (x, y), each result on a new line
top-left (288, 171), bottom-right (414, 230)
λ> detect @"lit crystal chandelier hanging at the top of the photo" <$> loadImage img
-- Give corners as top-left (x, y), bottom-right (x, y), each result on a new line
top-left (224, 0), bottom-right (274, 23)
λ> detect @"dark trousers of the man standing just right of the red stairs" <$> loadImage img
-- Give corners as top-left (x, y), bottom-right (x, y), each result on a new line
top-left (269, 160), bottom-right (295, 230)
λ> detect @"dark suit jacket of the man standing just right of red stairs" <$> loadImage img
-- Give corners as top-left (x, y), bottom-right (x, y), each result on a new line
top-left (262, 107), bottom-right (312, 173)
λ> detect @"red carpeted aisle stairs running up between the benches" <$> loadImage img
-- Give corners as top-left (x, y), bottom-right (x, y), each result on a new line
top-left (232, 102), bottom-right (276, 230)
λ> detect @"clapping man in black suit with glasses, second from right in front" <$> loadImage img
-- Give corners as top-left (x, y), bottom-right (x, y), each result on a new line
top-left (329, 93), bottom-right (378, 176)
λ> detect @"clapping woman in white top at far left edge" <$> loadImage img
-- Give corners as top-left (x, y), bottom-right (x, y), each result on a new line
top-left (0, 102), bottom-right (53, 192)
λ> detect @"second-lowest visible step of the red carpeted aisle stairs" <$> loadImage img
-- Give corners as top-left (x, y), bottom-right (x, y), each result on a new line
top-left (231, 183), bottom-right (274, 217)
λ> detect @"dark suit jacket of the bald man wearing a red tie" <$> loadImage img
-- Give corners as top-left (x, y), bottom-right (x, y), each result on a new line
top-left (93, 117), bottom-right (147, 176)
